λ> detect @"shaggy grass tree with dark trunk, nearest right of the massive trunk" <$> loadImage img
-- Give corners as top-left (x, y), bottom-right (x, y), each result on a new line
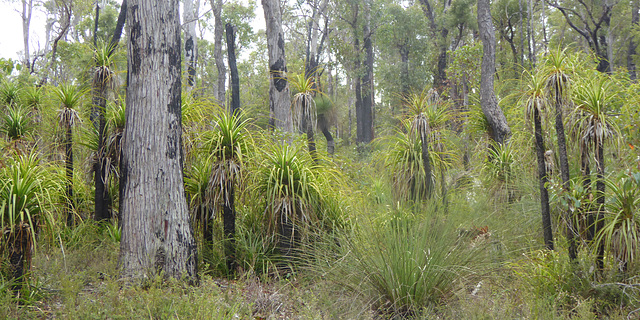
top-left (205, 112), bottom-right (251, 274)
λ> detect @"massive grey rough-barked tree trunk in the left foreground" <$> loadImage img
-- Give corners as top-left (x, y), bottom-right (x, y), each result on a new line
top-left (119, 0), bottom-right (197, 282)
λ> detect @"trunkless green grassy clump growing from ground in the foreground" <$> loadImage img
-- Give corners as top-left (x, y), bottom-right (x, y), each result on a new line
top-left (327, 212), bottom-right (485, 316)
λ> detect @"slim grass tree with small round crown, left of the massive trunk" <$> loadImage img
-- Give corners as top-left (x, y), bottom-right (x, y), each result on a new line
top-left (52, 83), bottom-right (85, 226)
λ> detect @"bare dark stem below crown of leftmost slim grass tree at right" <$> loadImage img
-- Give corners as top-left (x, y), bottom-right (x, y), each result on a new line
top-left (533, 108), bottom-right (553, 250)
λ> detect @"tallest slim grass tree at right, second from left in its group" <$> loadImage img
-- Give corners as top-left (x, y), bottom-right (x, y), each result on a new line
top-left (544, 50), bottom-right (577, 260)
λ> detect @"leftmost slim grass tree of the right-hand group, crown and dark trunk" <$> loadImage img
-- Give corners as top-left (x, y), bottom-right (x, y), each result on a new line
top-left (521, 73), bottom-right (553, 250)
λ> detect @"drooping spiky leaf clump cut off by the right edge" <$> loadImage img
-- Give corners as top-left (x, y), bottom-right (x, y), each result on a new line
top-left (595, 172), bottom-right (640, 272)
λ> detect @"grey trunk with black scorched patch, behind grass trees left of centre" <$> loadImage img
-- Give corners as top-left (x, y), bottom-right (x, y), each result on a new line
top-left (262, 0), bottom-right (293, 133)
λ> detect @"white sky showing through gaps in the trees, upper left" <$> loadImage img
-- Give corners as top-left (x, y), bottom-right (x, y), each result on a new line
top-left (0, 0), bottom-right (264, 60)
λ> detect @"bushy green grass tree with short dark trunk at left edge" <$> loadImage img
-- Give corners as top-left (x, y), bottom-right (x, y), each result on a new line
top-left (0, 153), bottom-right (60, 288)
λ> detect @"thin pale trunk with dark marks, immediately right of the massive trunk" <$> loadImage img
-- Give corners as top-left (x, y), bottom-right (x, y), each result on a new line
top-left (184, 0), bottom-right (200, 91)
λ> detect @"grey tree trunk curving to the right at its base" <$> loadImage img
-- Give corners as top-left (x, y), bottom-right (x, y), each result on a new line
top-left (478, 0), bottom-right (511, 144)
